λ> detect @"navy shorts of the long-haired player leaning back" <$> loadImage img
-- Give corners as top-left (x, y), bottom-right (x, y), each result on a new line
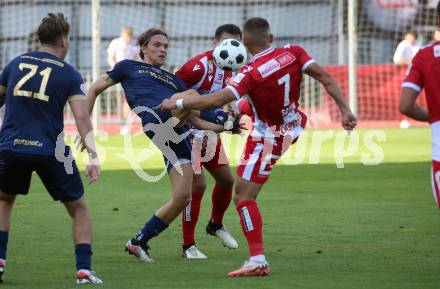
top-left (139, 109), bottom-right (192, 170)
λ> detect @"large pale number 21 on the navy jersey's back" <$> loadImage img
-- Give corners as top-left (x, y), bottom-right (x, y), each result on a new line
top-left (13, 63), bottom-right (52, 101)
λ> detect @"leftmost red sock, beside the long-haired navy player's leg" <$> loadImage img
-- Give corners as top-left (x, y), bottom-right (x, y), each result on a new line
top-left (182, 192), bottom-right (203, 246)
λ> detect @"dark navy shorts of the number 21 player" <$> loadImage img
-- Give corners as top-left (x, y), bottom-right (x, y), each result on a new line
top-left (0, 151), bottom-right (84, 203)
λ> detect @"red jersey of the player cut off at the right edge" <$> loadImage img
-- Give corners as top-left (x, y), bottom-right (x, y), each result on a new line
top-left (402, 41), bottom-right (440, 123)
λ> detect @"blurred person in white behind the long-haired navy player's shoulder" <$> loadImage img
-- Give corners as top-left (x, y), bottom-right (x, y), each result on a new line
top-left (107, 26), bottom-right (139, 135)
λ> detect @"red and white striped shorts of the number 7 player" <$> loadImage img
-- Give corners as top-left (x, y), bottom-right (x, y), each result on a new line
top-left (237, 113), bottom-right (307, 185)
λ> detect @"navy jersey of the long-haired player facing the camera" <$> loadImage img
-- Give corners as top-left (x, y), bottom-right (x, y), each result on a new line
top-left (107, 60), bottom-right (187, 109)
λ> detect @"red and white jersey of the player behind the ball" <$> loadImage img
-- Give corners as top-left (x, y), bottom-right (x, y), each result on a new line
top-left (176, 50), bottom-right (233, 94)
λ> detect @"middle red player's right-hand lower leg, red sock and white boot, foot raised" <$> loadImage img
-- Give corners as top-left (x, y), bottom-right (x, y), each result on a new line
top-left (206, 163), bottom-right (238, 249)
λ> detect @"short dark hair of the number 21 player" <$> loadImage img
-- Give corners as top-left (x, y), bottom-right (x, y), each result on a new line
top-left (37, 13), bottom-right (70, 45)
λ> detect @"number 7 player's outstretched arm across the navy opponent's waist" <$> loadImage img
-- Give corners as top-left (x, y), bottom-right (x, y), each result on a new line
top-left (161, 88), bottom-right (235, 110)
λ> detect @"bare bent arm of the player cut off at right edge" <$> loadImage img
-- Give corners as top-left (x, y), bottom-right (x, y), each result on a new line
top-left (399, 87), bottom-right (429, 122)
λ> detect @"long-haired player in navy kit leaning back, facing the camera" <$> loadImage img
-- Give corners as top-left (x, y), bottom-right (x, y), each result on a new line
top-left (87, 29), bottom-right (217, 262)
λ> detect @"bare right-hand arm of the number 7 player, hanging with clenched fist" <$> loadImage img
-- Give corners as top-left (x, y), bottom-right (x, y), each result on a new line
top-left (305, 63), bottom-right (357, 130)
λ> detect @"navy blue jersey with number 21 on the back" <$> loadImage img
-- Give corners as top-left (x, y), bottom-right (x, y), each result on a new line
top-left (0, 52), bottom-right (85, 155)
